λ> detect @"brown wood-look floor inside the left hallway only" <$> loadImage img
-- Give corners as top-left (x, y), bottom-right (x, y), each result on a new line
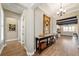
top-left (1, 41), bottom-right (27, 56)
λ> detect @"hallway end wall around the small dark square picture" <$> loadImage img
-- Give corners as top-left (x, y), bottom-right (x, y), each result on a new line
top-left (4, 10), bottom-right (20, 41)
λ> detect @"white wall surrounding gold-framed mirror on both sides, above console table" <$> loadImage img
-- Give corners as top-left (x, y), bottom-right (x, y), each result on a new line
top-left (35, 8), bottom-right (53, 37)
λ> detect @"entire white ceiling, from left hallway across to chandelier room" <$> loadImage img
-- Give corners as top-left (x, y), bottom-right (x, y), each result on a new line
top-left (2, 3), bottom-right (79, 14)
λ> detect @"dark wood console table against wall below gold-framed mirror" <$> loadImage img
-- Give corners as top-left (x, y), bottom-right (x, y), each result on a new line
top-left (36, 35), bottom-right (55, 53)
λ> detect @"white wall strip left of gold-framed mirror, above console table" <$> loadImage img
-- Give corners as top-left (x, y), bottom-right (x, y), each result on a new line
top-left (35, 8), bottom-right (44, 37)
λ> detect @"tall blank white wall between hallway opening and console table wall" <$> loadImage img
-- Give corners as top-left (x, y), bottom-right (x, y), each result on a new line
top-left (23, 8), bottom-right (34, 55)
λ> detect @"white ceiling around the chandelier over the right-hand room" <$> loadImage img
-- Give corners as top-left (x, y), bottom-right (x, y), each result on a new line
top-left (40, 3), bottom-right (79, 14)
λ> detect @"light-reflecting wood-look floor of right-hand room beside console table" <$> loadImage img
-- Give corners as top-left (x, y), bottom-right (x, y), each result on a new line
top-left (36, 36), bottom-right (79, 56)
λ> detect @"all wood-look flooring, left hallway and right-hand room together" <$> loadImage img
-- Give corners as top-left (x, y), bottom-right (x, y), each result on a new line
top-left (1, 36), bottom-right (79, 56)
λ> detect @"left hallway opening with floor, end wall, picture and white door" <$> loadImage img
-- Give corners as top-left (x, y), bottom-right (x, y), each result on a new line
top-left (1, 8), bottom-right (27, 56)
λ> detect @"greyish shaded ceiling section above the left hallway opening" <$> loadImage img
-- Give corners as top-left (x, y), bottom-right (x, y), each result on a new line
top-left (2, 3), bottom-right (23, 14)
